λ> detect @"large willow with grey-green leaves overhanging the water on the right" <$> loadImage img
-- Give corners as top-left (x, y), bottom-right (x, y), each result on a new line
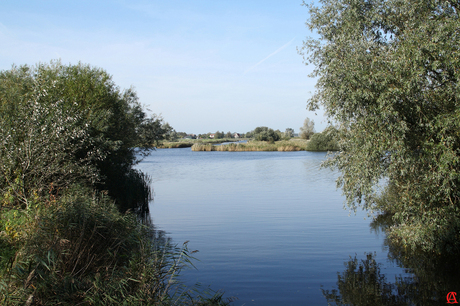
top-left (300, 0), bottom-right (460, 251)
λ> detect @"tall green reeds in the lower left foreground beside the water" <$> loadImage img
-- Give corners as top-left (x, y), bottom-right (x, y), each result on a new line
top-left (0, 189), bottom-right (228, 306)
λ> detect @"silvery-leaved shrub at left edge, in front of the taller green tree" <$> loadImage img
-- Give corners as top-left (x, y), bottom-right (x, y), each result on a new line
top-left (0, 75), bottom-right (101, 206)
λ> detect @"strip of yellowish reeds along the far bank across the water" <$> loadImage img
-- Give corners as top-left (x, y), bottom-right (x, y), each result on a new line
top-left (192, 139), bottom-right (307, 152)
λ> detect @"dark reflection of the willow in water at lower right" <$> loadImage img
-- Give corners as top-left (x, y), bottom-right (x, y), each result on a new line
top-left (322, 217), bottom-right (460, 306)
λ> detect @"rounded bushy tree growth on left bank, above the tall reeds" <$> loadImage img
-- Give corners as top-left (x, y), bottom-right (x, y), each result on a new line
top-left (0, 62), bottom-right (161, 212)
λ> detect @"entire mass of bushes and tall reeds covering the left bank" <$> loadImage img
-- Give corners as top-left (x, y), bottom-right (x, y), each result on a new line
top-left (0, 62), bottom-right (227, 305)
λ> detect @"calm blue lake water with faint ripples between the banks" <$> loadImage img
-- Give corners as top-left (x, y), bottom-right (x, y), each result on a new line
top-left (138, 148), bottom-right (402, 305)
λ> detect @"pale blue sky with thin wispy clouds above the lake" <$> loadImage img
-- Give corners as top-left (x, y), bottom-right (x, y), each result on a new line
top-left (0, 0), bottom-right (326, 133)
